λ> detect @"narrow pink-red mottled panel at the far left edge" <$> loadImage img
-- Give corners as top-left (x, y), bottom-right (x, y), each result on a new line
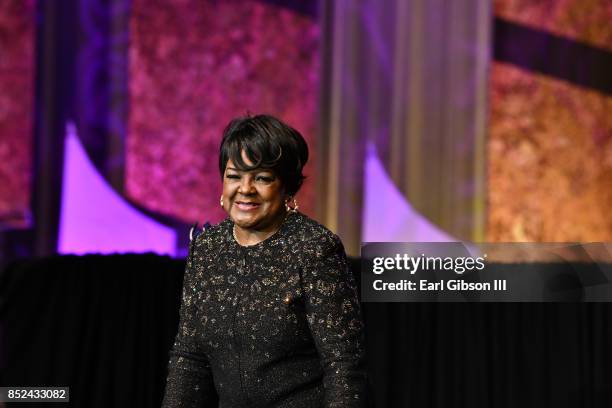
top-left (0, 0), bottom-right (34, 225)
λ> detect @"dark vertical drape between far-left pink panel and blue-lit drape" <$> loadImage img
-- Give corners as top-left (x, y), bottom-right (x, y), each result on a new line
top-left (31, 0), bottom-right (77, 256)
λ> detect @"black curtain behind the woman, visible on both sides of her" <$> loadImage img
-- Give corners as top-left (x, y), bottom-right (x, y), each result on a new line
top-left (0, 254), bottom-right (612, 408)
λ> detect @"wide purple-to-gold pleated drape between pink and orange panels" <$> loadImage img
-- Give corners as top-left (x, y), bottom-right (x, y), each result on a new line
top-left (319, 0), bottom-right (491, 254)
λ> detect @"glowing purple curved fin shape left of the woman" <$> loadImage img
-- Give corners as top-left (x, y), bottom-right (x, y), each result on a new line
top-left (58, 123), bottom-right (176, 256)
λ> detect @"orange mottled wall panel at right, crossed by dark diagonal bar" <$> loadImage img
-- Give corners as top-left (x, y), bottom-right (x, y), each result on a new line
top-left (488, 0), bottom-right (612, 241)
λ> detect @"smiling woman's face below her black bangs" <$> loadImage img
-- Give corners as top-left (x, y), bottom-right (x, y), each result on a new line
top-left (223, 152), bottom-right (286, 231)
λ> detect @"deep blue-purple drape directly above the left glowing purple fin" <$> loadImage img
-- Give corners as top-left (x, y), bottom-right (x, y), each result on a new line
top-left (74, 0), bottom-right (131, 194)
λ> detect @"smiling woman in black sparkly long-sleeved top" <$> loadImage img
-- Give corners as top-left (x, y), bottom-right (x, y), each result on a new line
top-left (163, 115), bottom-right (366, 408)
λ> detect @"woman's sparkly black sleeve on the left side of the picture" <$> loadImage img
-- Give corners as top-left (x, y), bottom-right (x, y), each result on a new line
top-left (162, 239), bottom-right (218, 408)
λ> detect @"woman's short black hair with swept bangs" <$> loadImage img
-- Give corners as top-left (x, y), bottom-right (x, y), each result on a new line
top-left (219, 115), bottom-right (308, 196)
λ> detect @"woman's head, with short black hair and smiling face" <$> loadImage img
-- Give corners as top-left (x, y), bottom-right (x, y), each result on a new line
top-left (219, 115), bottom-right (308, 239)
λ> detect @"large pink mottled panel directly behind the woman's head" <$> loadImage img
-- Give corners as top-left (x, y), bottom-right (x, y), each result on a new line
top-left (126, 0), bottom-right (319, 222)
